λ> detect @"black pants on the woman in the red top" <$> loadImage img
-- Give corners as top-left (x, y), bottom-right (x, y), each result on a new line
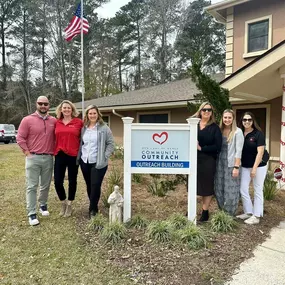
top-left (54, 151), bottom-right (78, 201)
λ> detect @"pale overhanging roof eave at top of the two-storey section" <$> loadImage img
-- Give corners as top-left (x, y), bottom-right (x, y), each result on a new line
top-left (204, 0), bottom-right (252, 23)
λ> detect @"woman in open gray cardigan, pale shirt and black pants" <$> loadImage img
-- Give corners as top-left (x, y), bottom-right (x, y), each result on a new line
top-left (77, 105), bottom-right (114, 218)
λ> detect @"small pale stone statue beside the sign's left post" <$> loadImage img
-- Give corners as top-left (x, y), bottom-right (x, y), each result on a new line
top-left (108, 185), bottom-right (124, 223)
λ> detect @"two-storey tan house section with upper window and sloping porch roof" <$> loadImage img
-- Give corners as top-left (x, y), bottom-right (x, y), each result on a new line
top-left (205, 0), bottom-right (285, 169)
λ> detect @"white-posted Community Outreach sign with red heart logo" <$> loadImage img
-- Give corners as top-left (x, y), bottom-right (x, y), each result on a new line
top-left (122, 117), bottom-right (199, 223)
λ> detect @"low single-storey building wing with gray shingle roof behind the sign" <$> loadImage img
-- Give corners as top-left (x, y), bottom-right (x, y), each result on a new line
top-left (70, 73), bottom-right (222, 145)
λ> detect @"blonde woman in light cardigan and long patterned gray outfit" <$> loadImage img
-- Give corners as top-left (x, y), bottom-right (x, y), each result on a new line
top-left (215, 109), bottom-right (244, 216)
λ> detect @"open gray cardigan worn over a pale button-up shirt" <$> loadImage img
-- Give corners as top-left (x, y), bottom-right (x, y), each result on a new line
top-left (77, 123), bottom-right (115, 169)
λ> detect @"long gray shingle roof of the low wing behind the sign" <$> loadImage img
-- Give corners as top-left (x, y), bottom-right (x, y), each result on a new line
top-left (72, 73), bottom-right (225, 111)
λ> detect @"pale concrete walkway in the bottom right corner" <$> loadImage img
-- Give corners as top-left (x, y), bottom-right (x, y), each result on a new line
top-left (226, 221), bottom-right (285, 285)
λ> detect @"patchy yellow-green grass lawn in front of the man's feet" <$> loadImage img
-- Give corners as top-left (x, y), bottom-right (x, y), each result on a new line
top-left (0, 144), bottom-right (131, 285)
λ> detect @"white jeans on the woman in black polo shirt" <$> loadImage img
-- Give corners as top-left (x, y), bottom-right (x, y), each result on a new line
top-left (240, 166), bottom-right (267, 217)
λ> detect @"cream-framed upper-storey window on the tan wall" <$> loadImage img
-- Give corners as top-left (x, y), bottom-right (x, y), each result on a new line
top-left (243, 16), bottom-right (272, 57)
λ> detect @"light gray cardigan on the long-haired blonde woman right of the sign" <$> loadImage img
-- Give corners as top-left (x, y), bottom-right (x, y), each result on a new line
top-left (225, 128), bottom-right (244, 167)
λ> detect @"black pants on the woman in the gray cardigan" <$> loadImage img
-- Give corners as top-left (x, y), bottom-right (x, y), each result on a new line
top-left (80, 159), bottom-right (108, 213)
